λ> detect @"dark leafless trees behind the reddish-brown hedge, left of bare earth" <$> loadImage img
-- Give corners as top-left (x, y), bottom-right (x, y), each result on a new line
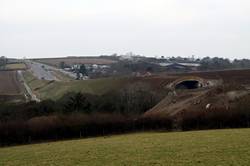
top-left (0, 83), bottom-right (166, 122)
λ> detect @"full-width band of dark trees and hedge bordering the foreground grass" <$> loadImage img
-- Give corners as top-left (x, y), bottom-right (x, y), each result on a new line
top-left (0, 84), bottom-right (250, 146)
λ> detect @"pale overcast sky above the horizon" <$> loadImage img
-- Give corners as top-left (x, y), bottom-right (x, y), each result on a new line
top-left (0, 0), bottom-right (250, 59)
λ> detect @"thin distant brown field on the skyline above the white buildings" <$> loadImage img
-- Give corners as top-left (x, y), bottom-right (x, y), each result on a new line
top-left (35, 57), bottom-right (116, 67)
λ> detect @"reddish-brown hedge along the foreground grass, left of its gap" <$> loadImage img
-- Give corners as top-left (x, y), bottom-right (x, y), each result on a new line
top-left (0, 113), bottom-right (172, 146)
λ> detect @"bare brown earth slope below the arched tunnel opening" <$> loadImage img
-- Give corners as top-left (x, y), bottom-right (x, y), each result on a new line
top-left (143, 84), bottom-right (250, 118)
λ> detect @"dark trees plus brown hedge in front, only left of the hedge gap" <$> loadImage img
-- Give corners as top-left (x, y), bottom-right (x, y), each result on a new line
top-left (0, 83), bottom-right (171, 146)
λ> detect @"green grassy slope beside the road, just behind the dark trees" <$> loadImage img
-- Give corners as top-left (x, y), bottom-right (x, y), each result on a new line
top-left (24, 71), bottom-right (128, 100)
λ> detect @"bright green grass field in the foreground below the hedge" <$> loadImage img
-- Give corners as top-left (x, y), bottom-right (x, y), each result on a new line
top-left (0, 129), bottom-right (250, 166)
